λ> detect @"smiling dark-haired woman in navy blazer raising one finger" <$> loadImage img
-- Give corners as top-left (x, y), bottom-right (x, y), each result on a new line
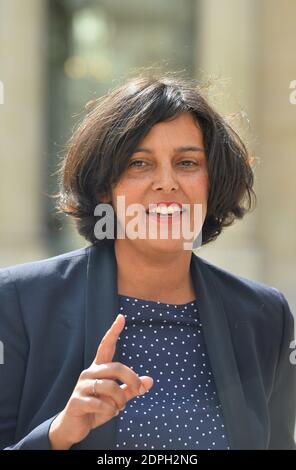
top-left (0, 78), bottom-right (296, 449)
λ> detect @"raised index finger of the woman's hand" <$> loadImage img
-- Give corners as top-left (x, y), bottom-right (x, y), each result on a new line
top-left (94, 314), bottom-right (125, 364)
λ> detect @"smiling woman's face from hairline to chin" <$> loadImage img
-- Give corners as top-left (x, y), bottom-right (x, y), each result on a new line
top-left (112, 113), bottom-right (208, 252)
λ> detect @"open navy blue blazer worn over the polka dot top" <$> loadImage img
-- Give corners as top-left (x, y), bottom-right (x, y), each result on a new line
top-left (0, 242), bottom-right (296, 450)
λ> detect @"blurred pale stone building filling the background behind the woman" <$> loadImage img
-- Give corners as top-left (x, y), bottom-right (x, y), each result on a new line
top-left (0, 0), bottom-right (296, 312)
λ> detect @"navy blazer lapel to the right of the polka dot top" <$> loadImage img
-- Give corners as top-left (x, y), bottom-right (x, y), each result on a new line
top-left (191, 254), bottom-right (258, 449)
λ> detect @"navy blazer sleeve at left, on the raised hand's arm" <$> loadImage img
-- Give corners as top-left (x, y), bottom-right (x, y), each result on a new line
top-left (0, 269), bottom-right (55, 449)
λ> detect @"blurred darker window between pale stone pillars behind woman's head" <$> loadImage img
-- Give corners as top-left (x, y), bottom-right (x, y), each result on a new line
top-left (46, 0), bottom-right (196, 252)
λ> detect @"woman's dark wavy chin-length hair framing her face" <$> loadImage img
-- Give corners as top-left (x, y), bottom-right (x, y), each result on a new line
top-left (57, 76), bottom-right (255, 244)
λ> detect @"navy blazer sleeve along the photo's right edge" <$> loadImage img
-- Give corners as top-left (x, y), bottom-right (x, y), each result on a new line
top-left (268, 293), bottom-right (296, 450)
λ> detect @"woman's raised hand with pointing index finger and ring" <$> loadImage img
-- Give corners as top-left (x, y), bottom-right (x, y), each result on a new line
top-left (49, 314), bottom-right (153, 449)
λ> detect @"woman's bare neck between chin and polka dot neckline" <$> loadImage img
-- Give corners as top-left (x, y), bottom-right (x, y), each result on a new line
top-left (115, 239), bottom-right (195, 304)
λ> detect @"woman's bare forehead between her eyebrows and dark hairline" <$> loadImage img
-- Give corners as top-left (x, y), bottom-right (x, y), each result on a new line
top-left (141, 113), bottom-right (203, 145)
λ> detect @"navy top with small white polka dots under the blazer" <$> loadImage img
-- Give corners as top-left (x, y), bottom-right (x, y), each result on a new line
top-left (116, 295), bottom-right (229, 450)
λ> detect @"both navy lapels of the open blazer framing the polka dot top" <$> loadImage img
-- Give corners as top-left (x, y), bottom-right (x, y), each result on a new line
top-left (75, 242), bottom-right (257, 450)
